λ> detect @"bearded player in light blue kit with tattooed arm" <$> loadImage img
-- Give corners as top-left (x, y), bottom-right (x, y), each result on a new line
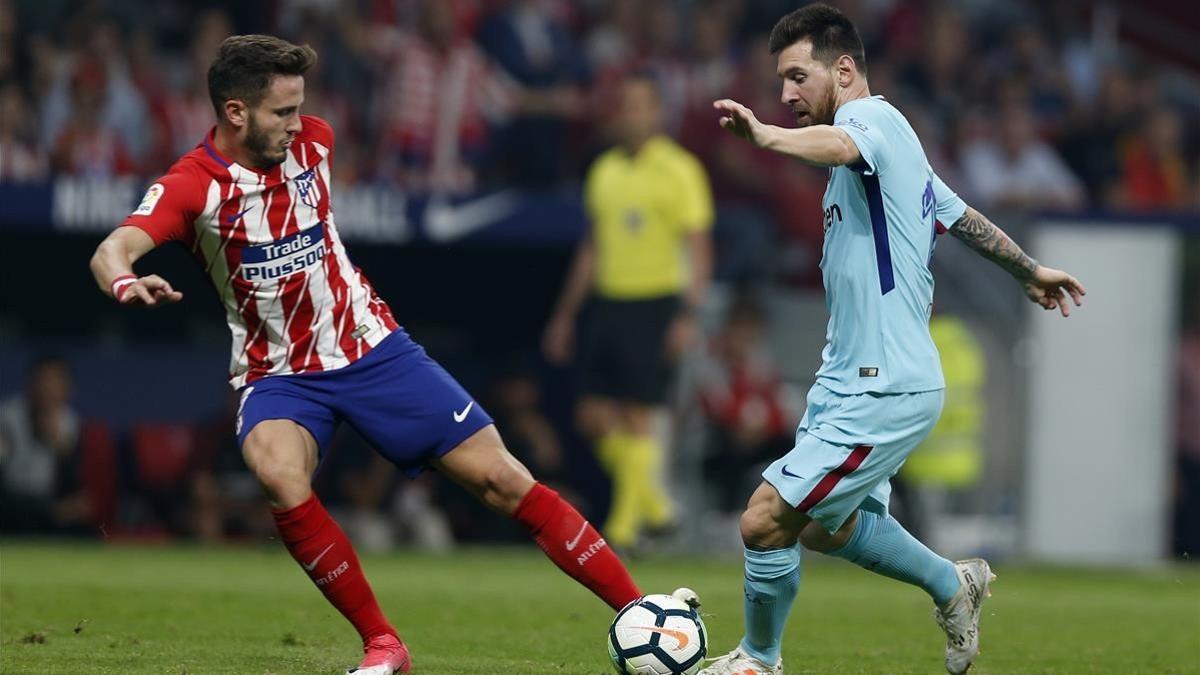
top-left (701, 5), bottom-right (1085, 675)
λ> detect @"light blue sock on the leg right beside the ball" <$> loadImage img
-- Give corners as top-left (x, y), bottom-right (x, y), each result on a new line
top-left (738, 543), bottom-right (800, 665)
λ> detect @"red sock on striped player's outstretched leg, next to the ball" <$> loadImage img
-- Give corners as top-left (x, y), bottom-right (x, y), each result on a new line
top-left (512, 483), bottom-right (642, 609)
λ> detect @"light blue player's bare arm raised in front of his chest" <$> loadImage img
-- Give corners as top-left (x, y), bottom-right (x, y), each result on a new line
top-left (713, 98), bottom-right (863, 167)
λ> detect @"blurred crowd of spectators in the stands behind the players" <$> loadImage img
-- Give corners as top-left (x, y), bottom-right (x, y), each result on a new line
top-left (0, 0), bottom-right (1200, 214)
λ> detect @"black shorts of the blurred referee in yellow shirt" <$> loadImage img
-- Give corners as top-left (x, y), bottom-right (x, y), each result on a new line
top-left (580, 295), bottom-right (679, 405)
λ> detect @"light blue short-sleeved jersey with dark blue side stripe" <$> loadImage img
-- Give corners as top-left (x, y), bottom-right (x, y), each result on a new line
top-left (817, 91), bottom-right (966, 394)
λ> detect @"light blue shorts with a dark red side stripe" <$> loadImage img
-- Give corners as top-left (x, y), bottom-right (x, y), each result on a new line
top-left (762, 383), bottom-right (944, 533)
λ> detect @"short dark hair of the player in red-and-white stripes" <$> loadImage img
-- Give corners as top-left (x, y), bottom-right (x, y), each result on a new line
top-left (209, 35), bottom-right (317, 120)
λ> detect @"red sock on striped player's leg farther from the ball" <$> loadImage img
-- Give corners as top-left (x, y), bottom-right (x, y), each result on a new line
top-left (272, 494), bottom-right (396, 641)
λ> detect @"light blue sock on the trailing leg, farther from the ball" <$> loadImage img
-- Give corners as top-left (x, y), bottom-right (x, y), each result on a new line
top-left (830, 509), bottom-right (959, 605)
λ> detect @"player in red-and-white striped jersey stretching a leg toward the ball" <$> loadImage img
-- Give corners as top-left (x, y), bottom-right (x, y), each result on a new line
top-left (91, 35), bottom-right (641, 675)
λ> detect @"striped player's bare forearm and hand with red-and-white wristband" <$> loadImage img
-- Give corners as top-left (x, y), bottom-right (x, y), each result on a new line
top-left (91, 227), bottom-right (184, 307)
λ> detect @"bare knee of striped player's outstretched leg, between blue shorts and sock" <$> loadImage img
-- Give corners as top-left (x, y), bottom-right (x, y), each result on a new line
top-left (431, 425), bottom-right (534, 514)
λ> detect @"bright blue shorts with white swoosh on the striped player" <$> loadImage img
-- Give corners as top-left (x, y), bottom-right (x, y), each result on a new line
top-left (236, 329), bottom-right (492, 478)
